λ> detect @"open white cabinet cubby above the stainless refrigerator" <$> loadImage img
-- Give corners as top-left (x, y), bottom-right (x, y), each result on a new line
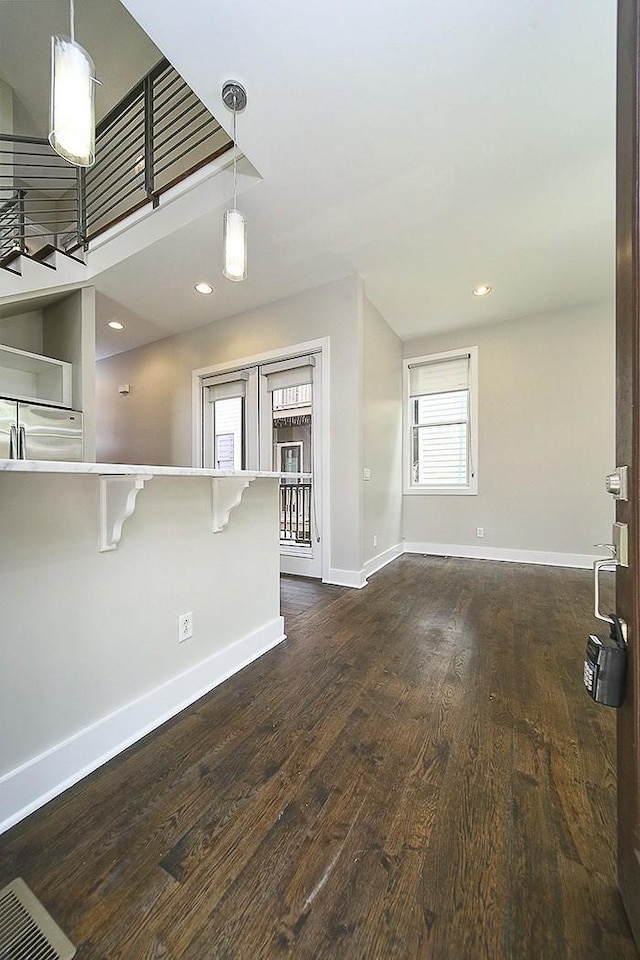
top-left (0, 345), bottom-right (72, 407)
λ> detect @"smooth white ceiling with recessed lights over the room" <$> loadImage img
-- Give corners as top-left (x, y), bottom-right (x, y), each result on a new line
top-left (0, 0), bottom-right (616, 355)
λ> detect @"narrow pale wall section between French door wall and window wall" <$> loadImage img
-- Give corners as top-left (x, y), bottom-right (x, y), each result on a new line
top-left (362, 288), bottom-right (402, 568)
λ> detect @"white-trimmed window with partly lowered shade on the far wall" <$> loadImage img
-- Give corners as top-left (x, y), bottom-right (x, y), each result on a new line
top-left (405, 347), bottom-right (478, 494)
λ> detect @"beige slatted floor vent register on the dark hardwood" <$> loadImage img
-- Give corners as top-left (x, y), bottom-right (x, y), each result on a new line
top-left (0, 877), bottom-right (76, 960)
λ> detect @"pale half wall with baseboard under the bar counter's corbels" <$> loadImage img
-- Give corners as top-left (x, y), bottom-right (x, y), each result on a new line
top-left (0, 472), bottom-right (282, 829)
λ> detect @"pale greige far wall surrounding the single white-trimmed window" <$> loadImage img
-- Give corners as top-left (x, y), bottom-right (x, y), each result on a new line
top-left (403, 303), bottom-right (615, 555)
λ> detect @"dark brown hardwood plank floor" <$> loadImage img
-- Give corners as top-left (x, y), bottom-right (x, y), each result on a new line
top-left (0, 556), bottom-right (638, 960)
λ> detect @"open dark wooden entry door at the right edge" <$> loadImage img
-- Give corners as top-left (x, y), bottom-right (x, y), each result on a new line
top-left (616, 0), bottom-right (640, 944)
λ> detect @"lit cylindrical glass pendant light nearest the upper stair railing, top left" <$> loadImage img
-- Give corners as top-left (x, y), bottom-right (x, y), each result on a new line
top-left (49, 0), bottom-right (97, 167)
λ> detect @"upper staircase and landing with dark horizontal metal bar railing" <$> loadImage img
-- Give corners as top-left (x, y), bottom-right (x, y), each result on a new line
top-left (0, 59), bottom-right (232, 303)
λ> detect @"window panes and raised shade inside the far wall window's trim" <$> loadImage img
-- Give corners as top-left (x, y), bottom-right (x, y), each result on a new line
top-left (409, 354), bottom-right (471, 488)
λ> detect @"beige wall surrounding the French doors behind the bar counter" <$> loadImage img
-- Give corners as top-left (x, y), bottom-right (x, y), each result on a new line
top-left (97, 277), bottom-right (362, 571)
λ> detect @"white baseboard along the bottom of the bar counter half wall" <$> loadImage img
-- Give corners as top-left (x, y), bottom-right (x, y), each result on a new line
top-left (0, 617), bottom-right (285, 833)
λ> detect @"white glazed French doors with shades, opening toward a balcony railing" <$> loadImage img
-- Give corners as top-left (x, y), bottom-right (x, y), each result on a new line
top-left (202, 353), bottom-right (323, 577)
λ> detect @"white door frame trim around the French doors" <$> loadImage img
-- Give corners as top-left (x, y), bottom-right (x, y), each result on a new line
top-left (191, 337), bottom-right (331, 582)
